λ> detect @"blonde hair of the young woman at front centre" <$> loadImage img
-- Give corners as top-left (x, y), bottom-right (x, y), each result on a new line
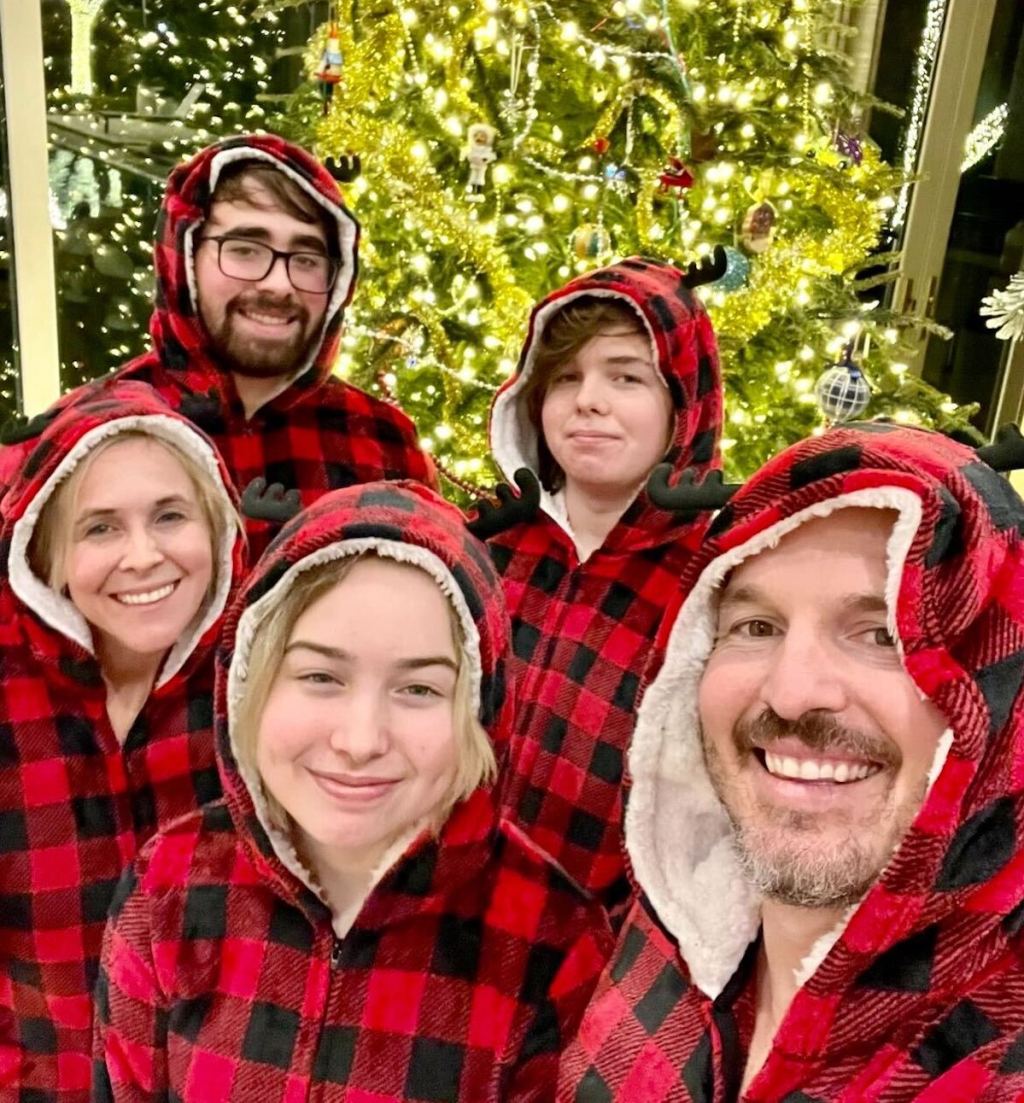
top-left (232, 552), bottom-right (498, 834)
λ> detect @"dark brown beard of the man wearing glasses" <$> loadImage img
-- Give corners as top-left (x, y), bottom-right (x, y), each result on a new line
top-left (204, 292), bottom-right (320, 379)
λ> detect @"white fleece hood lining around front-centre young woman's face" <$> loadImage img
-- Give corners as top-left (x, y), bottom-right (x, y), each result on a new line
top-left (227, 536), bottom-right (482, 917)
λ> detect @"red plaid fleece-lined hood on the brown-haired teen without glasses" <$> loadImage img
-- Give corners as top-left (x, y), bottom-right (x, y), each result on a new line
top-left (490, 257), bottom-right (722, 550)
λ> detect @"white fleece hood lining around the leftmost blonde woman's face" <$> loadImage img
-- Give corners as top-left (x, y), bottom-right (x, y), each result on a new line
top-left (9, 414), bottom-right (238, 688)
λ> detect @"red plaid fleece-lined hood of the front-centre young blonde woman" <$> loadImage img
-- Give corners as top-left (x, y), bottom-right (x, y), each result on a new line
top-left (216, 482), bottom-right (511, 930)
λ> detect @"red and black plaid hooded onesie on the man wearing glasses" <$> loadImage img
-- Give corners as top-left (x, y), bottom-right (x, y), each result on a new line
top-left (0, 135), bottom-right (437, 561)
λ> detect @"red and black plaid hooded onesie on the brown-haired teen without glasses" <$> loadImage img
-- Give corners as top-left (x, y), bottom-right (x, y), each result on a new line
top-left (488, 257), bottom-right (722, 907)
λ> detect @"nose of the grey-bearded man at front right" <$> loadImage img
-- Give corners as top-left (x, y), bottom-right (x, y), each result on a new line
top-left (760, 631), bottom-right (847, 721)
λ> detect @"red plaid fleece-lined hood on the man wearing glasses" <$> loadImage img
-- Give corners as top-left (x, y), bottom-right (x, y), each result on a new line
top-left (149, 135), bottom-right (359, 401)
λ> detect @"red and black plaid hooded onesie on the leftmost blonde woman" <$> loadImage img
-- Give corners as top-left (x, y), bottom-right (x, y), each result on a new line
top-left (0, 383), bottom-right (242, 1103)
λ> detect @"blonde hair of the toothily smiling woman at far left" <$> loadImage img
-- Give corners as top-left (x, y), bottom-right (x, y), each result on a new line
top-left (29, 429), bottom-right (242, 593)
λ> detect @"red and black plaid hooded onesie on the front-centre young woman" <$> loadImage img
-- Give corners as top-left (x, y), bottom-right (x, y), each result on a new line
top-left (94, 483), bottom-right (611, 1103)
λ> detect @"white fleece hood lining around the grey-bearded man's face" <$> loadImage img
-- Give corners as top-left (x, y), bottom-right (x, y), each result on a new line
top-left (625, 486), bottom-right (952, 998)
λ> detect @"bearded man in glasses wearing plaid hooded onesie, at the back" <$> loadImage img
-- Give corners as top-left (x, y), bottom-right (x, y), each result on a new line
top-left (0, 135), bottom-right (436, 558)
